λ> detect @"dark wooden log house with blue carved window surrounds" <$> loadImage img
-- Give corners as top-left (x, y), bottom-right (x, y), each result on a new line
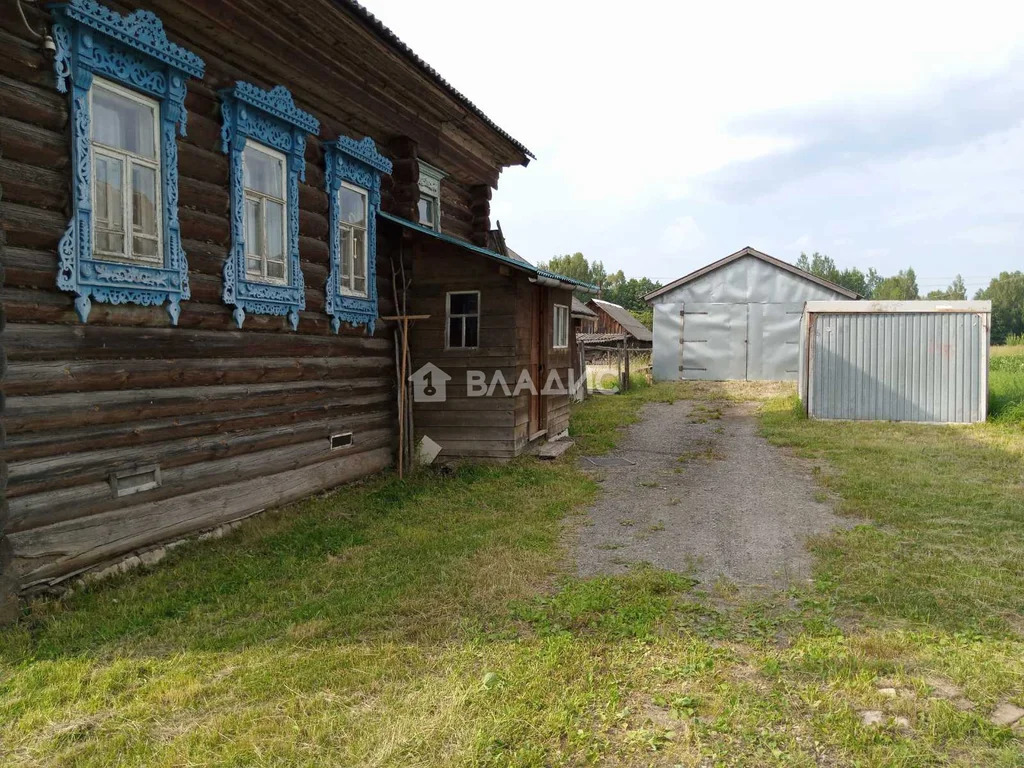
top-left (0, 0), bottom-right (593, 618)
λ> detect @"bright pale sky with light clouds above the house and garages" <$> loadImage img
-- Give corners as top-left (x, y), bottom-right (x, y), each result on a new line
top-left (364, 0), bottom-right (1024, 295)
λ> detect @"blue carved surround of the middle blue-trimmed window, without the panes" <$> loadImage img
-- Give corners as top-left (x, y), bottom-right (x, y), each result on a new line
top-left (220, 82), bottom-right (319, 331)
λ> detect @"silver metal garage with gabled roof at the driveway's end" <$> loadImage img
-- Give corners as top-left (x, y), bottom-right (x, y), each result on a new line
top-left (644, 248), bottom-right (859, 381)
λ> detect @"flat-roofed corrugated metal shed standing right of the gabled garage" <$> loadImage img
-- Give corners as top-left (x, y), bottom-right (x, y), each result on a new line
top-left (800, 301), bottom-right (992, 423)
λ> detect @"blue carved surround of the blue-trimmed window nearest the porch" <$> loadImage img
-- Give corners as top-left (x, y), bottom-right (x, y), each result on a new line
top-left (324, 136), bottom-right (392, 334)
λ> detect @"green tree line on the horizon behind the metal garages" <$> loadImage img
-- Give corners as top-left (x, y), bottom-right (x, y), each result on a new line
top-left (539, 252), bottom-right (1024, 344)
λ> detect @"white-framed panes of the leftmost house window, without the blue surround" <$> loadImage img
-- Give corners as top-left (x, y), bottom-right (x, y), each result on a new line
top-left (89, 77), bottom-right (164, 264)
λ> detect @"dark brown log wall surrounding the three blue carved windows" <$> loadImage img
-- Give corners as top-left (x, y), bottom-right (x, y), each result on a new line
top-left (0, 0), bottom-right (514, 593)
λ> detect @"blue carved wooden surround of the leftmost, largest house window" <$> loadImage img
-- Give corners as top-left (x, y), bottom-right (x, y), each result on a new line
top-left (49, 0), bottom-right (206, 326)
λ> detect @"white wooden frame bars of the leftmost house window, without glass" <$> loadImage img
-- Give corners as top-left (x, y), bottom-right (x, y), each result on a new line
top-left (89, 76), bottom-right (164, 264)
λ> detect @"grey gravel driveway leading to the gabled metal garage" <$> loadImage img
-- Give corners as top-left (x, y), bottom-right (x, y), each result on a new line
top-left (574, 400), bottom-right (852, 588)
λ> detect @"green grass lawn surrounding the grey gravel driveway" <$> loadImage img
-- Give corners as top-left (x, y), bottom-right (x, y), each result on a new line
top-left (0, 355), bottom-right (1024, 768)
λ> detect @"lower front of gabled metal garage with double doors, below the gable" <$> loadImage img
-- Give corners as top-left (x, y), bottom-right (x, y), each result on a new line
top-left (653, 302), bottom-right (803, 381)
